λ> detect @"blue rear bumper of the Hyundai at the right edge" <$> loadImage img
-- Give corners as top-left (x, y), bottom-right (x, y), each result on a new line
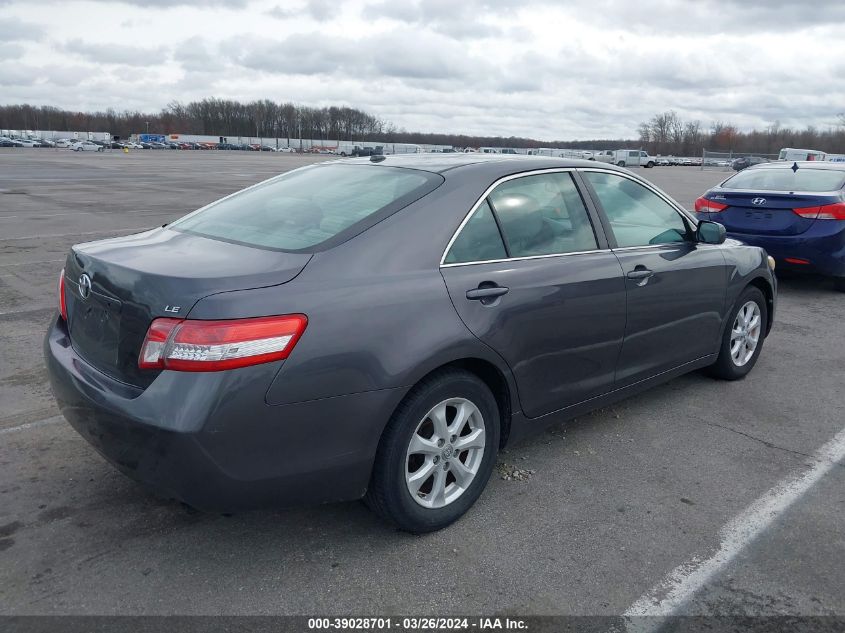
top-left (713, 221), bottom-right (845, 277)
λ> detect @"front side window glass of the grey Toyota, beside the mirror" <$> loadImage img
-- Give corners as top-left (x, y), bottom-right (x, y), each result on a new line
top-left (584, 171), bottom-right (689, 248)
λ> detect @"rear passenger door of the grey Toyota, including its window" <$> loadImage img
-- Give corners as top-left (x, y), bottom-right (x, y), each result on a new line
top-left (441, 170), bottom-right (625, 417)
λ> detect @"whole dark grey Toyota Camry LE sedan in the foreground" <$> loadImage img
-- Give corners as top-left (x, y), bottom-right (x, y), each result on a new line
top-left (44, 154), bottom-right (777, 532)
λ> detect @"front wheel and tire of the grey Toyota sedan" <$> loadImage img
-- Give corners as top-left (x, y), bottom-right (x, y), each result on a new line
top-left (708, 286), bottom-right (769, 380)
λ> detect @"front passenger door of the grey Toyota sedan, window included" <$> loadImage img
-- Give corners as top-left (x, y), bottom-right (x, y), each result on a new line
top-left (583, 170), bottom-right (728, 388)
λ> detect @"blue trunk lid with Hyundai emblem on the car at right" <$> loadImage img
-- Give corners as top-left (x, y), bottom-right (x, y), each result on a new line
top-left (707, 191), bottom-right (839, 235)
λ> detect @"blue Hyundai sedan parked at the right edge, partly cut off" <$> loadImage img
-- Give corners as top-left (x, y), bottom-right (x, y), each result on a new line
top-left (695, 161), bottom-right (845, 291)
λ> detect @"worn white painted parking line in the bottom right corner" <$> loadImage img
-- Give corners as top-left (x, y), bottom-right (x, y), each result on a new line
top-left (623, 422), bottom-right (845, 631)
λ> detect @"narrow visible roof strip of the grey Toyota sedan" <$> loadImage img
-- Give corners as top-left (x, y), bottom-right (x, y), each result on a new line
top-left (331, 153), bottom-right (618, 174)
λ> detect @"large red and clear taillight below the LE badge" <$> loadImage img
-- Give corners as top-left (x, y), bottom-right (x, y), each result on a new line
top-left (138, 314), bottom-right (308, 371)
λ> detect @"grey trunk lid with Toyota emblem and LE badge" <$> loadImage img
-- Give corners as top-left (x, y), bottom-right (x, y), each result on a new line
top-left (65, 228), bottom-right (311, 388)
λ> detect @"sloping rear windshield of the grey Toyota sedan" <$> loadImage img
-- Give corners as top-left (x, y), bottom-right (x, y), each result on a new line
top-left (169, 165), bottom-right (442, 251)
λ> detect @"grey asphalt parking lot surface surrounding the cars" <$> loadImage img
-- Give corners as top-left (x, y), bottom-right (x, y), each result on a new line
top-left (0, 149), bottom-right (845, 615)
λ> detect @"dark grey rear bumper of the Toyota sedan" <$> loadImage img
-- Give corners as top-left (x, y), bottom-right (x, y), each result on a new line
top-left (44, 318), bottom-right (404, 511)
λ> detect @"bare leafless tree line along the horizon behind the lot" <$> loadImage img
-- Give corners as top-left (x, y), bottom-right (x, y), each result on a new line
top-left (0, 97), bottom-right (845, 156)
